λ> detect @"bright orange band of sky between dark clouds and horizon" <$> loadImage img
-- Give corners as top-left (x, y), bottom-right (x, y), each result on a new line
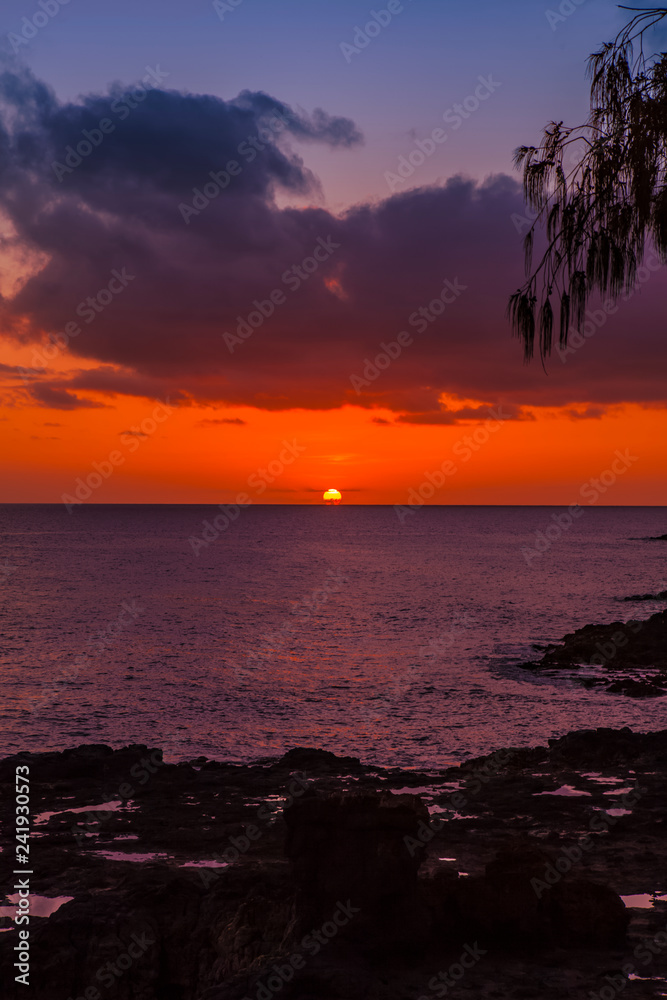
top-left (0, 350), bottom-right (667, 505)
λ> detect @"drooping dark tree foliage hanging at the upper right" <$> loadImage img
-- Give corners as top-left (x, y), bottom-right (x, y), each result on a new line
top-left (508, 7), bottom-right (667, 360)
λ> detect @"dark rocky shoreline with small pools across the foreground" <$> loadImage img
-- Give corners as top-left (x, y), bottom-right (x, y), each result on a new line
top-left (0, 729), bottom-right (667, 1000)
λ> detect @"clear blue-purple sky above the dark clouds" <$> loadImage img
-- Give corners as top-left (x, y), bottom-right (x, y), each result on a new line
top-left (0, 0), bottom-right (623, 210)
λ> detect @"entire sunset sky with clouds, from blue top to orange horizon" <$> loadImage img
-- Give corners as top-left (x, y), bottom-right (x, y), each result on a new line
top-left (0, 0), bottom-right (667, 505)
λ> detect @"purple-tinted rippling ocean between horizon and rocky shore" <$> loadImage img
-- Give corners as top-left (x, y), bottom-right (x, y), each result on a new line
top-left (0, 505), bottom-right (667, 767)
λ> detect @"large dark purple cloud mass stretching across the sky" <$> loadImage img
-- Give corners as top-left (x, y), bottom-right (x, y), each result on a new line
top-left (0, 71), bottom-right (667, 424)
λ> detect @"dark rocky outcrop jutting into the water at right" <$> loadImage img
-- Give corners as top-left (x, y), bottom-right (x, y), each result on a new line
top-left (521, 597), bottom-right (667, 698)
